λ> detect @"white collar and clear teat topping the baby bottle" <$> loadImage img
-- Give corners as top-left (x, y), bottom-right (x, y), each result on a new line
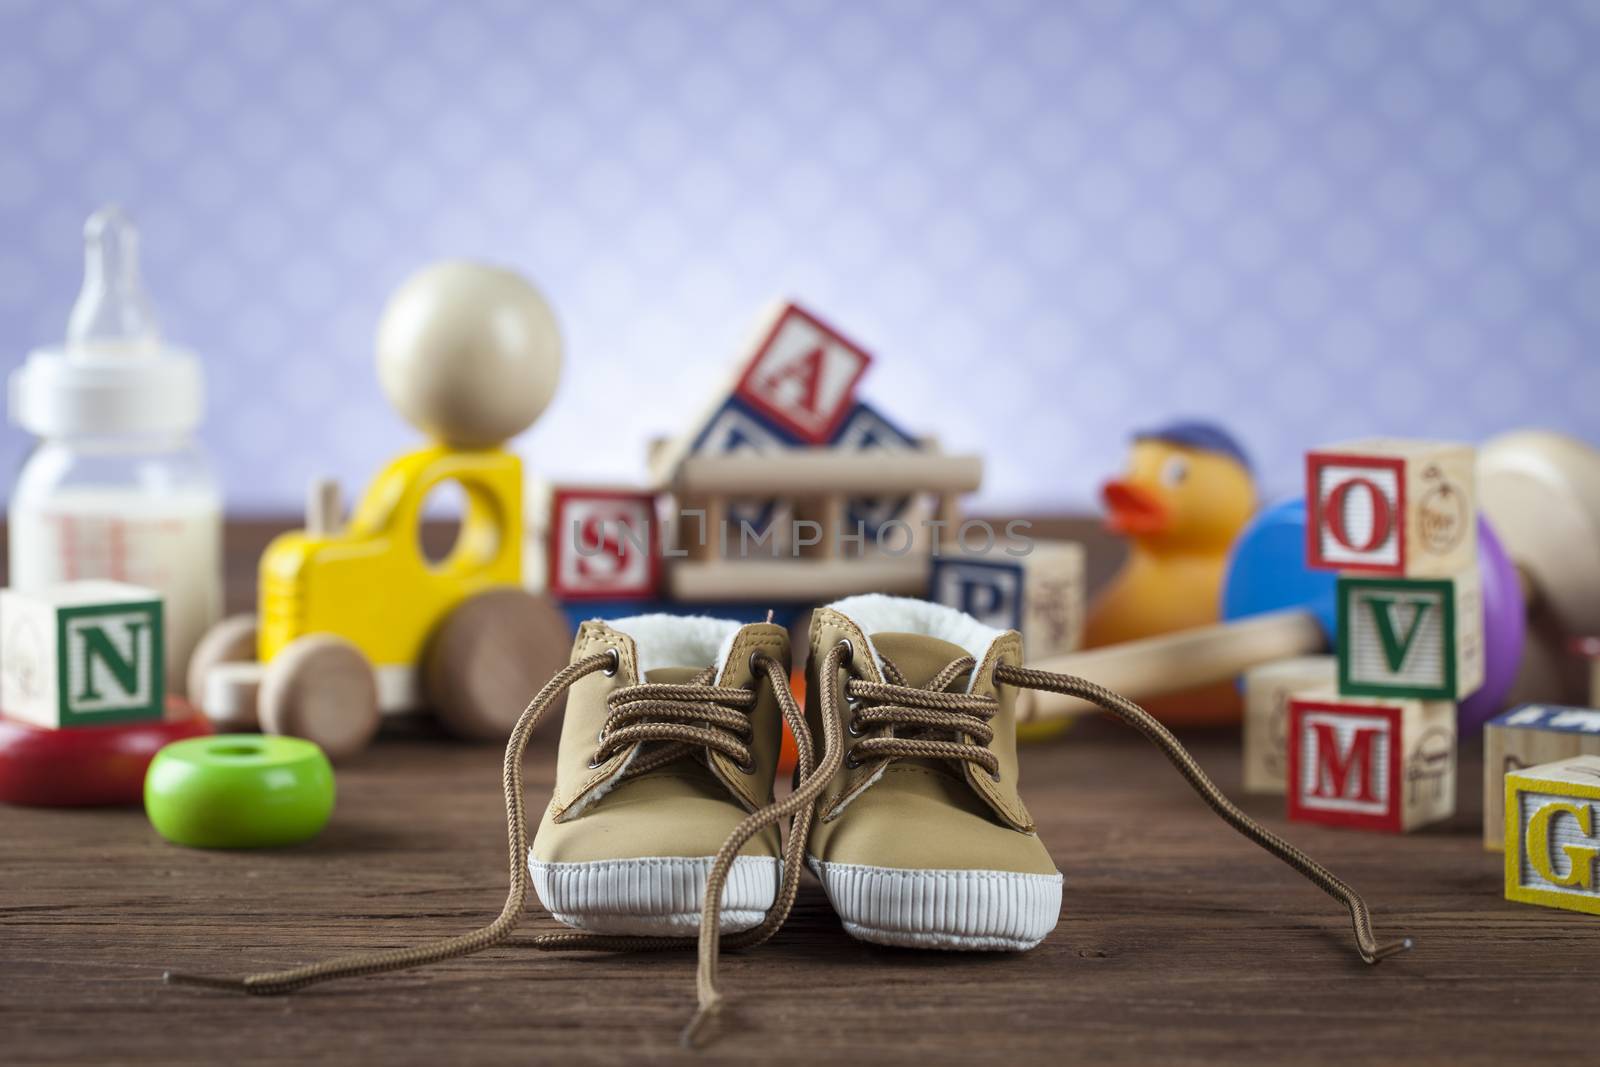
top-left (10, 206), bottom-right (205, 437)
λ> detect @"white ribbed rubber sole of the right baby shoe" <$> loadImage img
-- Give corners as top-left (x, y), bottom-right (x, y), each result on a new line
top-left (806, 856), bottom-right (1061, 952)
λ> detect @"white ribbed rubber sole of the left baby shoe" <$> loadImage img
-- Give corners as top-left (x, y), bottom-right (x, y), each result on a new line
top-left (528, 853), bottom-right (782, 936)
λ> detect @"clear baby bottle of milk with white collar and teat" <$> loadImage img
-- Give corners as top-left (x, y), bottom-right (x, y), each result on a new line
top-left (10, 206), bottom-right (222, 694)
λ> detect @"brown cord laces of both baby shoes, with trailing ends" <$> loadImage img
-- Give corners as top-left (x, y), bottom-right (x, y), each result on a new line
top-left (165, 641), bottom-right (1411, 1046)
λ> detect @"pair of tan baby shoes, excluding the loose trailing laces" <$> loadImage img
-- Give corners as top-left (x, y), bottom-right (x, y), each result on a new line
top-left (530, 597), bottom-right (1061, 950)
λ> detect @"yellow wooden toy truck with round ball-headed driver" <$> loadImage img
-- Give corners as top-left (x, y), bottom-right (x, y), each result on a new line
top-left (189, 262), bottom-right (571, 758)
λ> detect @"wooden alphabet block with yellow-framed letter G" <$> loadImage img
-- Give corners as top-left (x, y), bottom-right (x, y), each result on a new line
top-left (1506, 755), bottom-right (1600, 915)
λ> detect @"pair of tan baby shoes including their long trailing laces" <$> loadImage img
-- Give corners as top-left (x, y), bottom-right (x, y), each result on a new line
top-left (168, 595), bottom-right (1410, 1043)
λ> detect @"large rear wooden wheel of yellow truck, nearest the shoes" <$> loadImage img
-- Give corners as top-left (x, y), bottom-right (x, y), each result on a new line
top-left (422, 589), bottom-right (573, 741)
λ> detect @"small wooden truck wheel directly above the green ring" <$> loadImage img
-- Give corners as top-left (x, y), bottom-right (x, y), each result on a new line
top-left (261, 633), bottom-right (379, 760)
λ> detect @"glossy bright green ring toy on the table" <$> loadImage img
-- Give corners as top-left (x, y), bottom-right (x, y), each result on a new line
top-left (144, 734), bottom-right (333, 848)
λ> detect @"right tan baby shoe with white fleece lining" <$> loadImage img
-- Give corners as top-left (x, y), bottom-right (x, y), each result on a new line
top-left (806, 597), bottom-right (1061, 950)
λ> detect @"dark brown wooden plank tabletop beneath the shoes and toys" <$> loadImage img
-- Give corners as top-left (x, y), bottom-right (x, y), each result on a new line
top-left (0, 528), bottom-right (1600, 1064)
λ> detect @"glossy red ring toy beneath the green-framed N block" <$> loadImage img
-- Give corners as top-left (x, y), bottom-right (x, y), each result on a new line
top-left (0, 697), bottom-right (211, 808)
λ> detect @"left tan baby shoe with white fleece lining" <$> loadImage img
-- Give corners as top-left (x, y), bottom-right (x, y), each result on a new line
top-left (528, 614), bottom-right (789, 936)
